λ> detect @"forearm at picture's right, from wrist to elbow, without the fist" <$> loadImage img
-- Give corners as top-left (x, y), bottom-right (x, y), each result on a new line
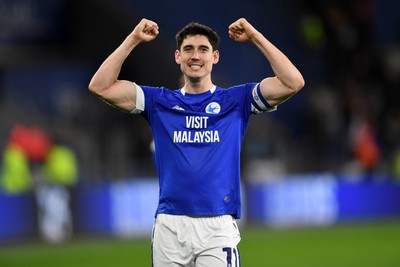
top-left (251, 32), bottom-right (304, 91)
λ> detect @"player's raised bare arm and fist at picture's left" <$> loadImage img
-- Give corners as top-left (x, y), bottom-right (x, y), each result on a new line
top-left (89, 19), bottom-right (158, 112)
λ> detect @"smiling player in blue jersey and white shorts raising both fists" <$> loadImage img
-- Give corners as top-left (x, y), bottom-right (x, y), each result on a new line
top-left (89, 18), bottom-right (304, 267)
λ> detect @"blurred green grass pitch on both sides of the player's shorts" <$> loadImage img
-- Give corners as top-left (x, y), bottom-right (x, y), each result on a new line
top-left (0, 221), bottom-right (400, 267)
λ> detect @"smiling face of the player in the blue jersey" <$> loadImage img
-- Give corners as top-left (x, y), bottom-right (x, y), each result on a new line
top-left (175, 35), bottom-right (219, 80)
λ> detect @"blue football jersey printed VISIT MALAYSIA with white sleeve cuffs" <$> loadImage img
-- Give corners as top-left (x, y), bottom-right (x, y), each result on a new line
top-left (137, 83), bottom-right (273, 218)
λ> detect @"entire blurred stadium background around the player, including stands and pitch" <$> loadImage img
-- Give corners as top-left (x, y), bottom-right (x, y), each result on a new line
top-left (0, 0), bottom-right (400, 267)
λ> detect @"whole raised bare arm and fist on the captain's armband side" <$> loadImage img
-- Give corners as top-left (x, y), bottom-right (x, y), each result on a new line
top-left (229, 18), bottom-right (304, 106)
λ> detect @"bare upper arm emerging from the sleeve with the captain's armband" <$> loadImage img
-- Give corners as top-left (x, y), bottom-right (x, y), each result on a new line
top-left (260, 77), bottom-right (295, 106)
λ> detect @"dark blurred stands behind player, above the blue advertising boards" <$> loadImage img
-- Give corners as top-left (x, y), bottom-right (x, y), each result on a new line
top-left (0, 0), bottom-right (400, 181)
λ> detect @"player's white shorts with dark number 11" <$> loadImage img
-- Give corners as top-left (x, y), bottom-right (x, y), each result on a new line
top-left (152, 214), bottom-right (241, 267)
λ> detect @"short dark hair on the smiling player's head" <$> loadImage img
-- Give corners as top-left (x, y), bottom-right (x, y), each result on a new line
top-left (175, 22), bottom-right (220, 50)
